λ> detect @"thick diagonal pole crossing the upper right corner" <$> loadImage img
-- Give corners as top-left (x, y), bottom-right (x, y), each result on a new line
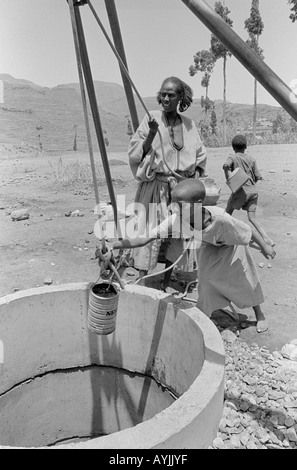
top-left (182, 0), bottom-right (297, 121)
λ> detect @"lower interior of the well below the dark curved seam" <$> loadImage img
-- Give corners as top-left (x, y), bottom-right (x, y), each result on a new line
top-left (0, 366), bottom-right (175, 447)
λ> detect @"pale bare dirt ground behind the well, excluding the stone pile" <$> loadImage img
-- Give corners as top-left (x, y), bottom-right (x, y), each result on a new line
top-left (0, 143), bottom-right (297, 351)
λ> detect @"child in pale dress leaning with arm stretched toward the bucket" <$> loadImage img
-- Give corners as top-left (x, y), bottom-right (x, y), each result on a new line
top-left (99, 179), bottom-right (275, 333)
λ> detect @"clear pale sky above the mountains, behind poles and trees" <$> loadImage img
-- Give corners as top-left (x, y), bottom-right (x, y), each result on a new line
top-left (0, 0), bottom-right (297, 106)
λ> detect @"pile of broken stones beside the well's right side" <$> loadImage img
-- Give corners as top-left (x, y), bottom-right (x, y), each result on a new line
top-left (210, 330), bottom-right (297, 449)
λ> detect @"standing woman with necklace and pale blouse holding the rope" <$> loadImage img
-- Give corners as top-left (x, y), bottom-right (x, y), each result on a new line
top-left (128, 77), bottom-right (206, 289)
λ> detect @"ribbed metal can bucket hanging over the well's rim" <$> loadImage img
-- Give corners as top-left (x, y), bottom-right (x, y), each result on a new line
top-left (88, 280), bottom-right (120, 335)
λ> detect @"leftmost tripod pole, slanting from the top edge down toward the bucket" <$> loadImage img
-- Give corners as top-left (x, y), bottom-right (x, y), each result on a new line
top-left (74, 5), bottom-right (121, 238)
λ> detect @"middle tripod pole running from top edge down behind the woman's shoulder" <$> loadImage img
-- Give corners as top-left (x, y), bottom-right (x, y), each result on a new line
top-left (105, 0), bottom-right (139, 132)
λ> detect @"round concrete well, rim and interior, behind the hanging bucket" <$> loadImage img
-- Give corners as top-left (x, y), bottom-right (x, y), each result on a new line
top-left (0, 284), bottom-right (224, 448)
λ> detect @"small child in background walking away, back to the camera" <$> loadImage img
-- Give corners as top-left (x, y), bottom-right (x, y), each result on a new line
top-left (223, 134), bottom-right (275, 246)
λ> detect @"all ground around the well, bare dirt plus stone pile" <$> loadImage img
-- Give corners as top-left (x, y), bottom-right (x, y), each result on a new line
top-left (0, 145), bottom-right (297, 449)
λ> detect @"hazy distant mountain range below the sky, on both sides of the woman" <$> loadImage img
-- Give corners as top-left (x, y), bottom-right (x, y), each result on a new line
top-left (0, 74), bottom-right (280, 152)
